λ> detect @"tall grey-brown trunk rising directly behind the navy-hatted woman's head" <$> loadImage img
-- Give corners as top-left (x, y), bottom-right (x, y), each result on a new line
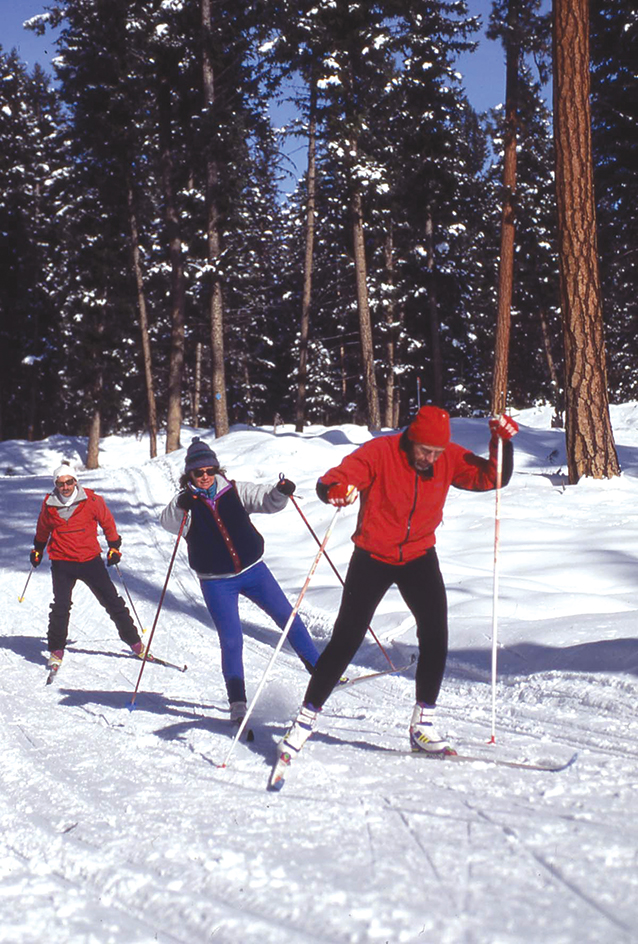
top-left (201, 0), bottom-right (230, 436)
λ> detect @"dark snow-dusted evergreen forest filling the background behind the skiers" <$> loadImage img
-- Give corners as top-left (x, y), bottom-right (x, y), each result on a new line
top-left (0, 0), bottom-right (638, 465)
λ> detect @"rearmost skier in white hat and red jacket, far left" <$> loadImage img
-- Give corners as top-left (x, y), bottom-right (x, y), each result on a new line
top-left (30, 465), bottom-right (144, 669)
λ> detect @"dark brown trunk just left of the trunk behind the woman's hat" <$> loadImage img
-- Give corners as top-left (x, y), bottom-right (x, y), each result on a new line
top-left (158, 75), bottom-right (186, 453)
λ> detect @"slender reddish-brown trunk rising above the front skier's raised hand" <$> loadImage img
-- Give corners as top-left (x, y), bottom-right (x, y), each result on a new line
top-left (490, 0), bottom-right (520, 416)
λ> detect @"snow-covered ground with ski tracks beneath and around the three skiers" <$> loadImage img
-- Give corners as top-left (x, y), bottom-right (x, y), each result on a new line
top-left (0, 404), bottom-right (638, 944)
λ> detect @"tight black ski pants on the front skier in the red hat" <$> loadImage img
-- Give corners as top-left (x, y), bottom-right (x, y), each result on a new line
top-left (304, 547), bottom-right (448, 708)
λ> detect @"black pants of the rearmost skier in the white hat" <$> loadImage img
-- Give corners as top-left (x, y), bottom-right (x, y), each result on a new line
top-left (47, 557), bottom-right (140, 652)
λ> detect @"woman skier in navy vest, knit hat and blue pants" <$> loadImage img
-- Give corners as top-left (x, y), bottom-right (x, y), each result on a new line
top-left (160, 438), bottom-right (319, 724)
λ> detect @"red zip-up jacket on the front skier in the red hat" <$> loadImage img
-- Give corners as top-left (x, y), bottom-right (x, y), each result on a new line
top-left (319, 433), bottom-right (512, 564)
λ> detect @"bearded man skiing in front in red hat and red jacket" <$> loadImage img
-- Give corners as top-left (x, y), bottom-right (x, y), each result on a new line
top-left (276, 406), bottom-right (518, 766)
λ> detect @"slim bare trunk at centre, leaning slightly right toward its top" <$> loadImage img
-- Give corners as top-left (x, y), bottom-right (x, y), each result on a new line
top-left (295, 74), bottom-right (317, 433)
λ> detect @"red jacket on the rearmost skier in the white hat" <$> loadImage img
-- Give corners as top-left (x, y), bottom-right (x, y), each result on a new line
top-left (35, 486), bottom-right (118, 561)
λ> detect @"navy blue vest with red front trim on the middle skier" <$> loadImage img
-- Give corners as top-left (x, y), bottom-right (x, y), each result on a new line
top-left (186, 483), bottom-right (264, 576)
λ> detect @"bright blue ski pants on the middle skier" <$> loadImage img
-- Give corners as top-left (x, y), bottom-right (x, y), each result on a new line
top-left (200, 561), bottom-right (319, 701)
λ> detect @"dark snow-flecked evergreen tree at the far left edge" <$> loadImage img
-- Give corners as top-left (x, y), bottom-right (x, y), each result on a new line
top-left (0, 50), bottom-right (65, 439)
